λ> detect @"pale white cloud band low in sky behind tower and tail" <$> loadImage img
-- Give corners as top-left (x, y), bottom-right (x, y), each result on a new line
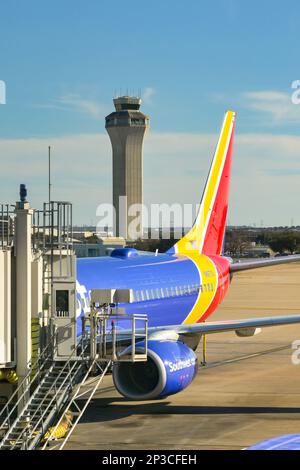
top-left (0, 133), bottom-right (300, 225)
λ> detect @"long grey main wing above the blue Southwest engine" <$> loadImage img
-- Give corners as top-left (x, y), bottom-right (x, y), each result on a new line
top-left (149, 314), bottom-right (300, 339)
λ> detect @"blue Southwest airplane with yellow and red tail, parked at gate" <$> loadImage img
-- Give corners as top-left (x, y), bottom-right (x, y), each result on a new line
top-left (77, 111), bottom-right (300, 400)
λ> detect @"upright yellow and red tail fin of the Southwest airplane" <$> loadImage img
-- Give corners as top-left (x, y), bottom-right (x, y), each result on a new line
top-left (168, 111), bottom-right (235, 255)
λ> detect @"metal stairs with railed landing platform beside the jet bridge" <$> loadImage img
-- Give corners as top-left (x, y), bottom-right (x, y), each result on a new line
top-left (0, 309), bottom-right (147, 450)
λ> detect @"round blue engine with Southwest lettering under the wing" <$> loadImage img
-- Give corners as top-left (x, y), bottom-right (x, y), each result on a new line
top-left (113, 340), bottom-right (198, 400)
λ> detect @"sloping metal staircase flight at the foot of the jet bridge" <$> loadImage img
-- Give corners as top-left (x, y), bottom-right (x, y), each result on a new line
top-left (0, 344), bottom-right (86, 450)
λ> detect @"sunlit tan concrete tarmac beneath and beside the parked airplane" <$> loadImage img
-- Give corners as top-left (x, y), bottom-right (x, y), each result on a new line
top-left (65, 263), bottom-right (300, 450)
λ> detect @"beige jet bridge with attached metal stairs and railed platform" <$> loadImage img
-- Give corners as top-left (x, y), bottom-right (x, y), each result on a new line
top-left (0, 189), bottom-right (147, 449)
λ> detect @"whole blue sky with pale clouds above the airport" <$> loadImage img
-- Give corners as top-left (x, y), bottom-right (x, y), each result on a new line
top-left (0, 0), bottom-right (300, 225)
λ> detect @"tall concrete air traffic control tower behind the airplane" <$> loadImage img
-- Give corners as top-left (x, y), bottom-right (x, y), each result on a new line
top-left (105, 96), bottom-right (149, 240)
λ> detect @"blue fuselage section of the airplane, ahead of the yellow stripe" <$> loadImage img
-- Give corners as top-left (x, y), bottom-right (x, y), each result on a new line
top-left (77, 254), bottom-right (201, 330)
